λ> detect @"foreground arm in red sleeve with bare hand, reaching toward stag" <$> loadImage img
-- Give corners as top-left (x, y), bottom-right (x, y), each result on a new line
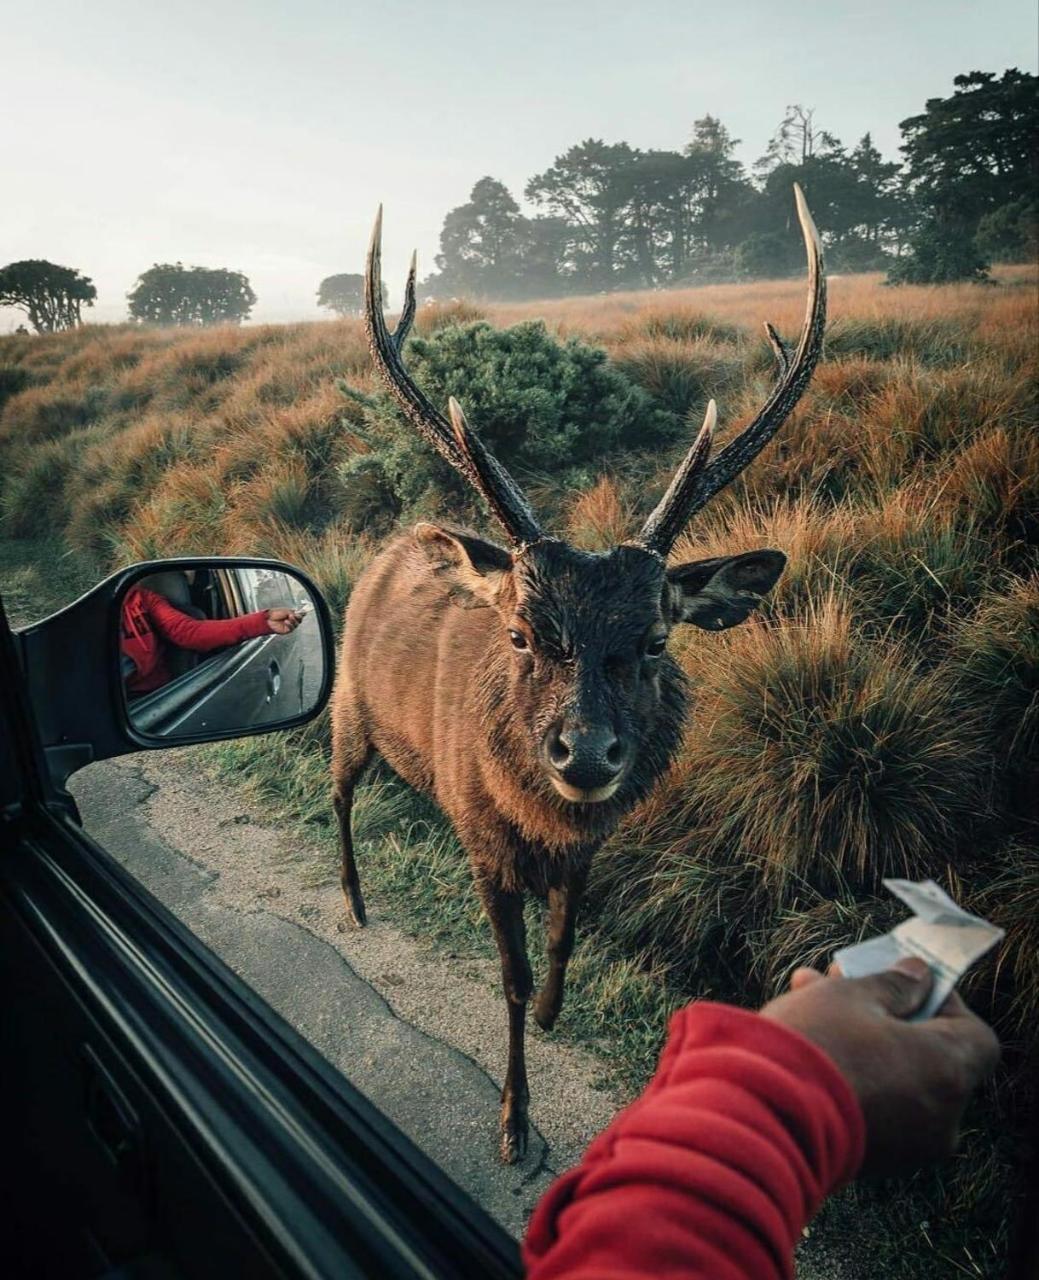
top-left (525, 970), bottom-right (998, 1280)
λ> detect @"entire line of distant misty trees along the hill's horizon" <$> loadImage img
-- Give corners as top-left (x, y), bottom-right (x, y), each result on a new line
top-left (0, 68), bottom-right (1039, 333)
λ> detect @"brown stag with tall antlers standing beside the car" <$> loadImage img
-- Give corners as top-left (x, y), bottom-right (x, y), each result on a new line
top-left (333, 188), bottom-right (825, 1164)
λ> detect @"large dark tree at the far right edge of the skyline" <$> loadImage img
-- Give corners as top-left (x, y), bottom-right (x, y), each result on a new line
top-left (891, 68), bottom-right (1039, 282)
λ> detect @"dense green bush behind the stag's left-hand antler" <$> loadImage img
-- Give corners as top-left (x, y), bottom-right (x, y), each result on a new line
top-left (339, 321), bottom-right (681, 527)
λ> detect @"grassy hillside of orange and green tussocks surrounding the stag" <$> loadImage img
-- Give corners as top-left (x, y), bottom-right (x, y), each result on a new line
top-left (0, 270), bottom-right (1039, 1276)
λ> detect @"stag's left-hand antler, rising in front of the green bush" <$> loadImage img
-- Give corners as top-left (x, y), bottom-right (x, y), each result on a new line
top-left (365, 205), bottom-right (541, 547)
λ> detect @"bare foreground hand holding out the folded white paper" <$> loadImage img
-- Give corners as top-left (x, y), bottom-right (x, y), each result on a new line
top-left (761, 957), bottom-right (999, 1175)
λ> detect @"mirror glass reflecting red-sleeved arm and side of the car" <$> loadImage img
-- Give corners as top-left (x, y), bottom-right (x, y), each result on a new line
top-left (119, 564), bottom-right (325, 741)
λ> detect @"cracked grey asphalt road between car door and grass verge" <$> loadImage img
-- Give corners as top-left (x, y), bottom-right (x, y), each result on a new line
top-left (70, 748), bottom-right (618, 1235)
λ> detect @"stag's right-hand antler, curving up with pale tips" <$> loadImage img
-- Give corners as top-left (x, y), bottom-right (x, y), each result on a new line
top-left (636, 183), bottom-right (827, 557)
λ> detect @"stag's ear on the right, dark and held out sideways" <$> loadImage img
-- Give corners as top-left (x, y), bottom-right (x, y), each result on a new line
top-left (668, 550), bottom-right (787, 631)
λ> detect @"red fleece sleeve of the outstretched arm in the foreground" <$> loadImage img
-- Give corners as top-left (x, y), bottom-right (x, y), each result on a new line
top-left (523, 1001), bottom-right (865, 1280)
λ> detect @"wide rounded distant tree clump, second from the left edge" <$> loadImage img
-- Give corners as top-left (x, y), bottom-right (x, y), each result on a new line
top-left (127, 262), bottom-right (256, 325)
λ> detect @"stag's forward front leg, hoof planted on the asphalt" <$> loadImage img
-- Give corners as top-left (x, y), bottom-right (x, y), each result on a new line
top-left (476, 876), bottom-right (534, 1165)
